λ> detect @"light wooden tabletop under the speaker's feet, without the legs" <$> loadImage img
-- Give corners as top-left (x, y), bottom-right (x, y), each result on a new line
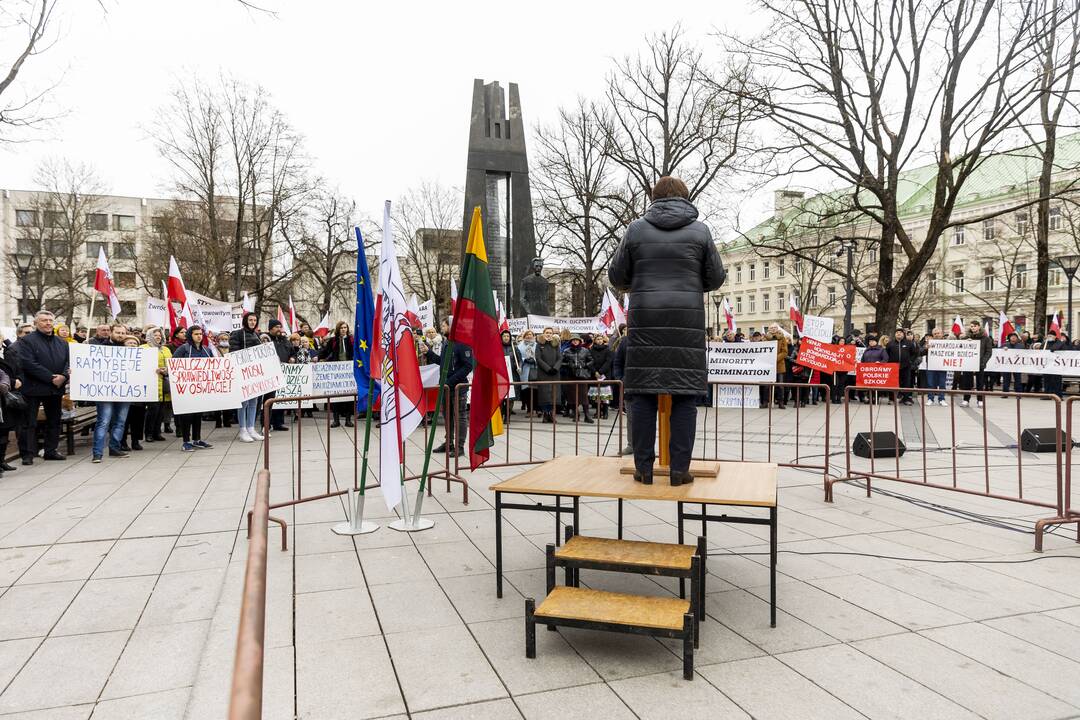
top-left (490, 456), bottom-right (777, 507)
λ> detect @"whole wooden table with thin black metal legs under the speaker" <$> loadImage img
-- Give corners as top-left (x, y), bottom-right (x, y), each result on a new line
top-left (490, 456), bottom-right (777, 627)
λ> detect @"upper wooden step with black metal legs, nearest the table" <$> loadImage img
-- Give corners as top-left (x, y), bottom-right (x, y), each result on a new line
top-left (548, 526), bottom-right (707, 621)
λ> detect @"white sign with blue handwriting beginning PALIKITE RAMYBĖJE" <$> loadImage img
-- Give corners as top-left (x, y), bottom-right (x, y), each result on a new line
top-left (68, 342), bottom-right (158, 403)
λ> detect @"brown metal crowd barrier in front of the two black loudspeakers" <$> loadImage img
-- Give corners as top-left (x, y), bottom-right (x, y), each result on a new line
top-left (825, 386), bottom-right (1075, 551)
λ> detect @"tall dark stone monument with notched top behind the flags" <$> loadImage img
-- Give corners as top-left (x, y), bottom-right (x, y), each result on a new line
top-left (461, 79), bottom-right (535, 317)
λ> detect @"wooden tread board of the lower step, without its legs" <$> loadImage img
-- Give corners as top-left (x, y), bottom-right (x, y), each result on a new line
top-left (535, 586), bottom-right (690, 631)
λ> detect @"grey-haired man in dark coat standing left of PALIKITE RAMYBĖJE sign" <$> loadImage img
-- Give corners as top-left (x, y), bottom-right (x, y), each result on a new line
top-left (15, 310), bottom-right (70, 465)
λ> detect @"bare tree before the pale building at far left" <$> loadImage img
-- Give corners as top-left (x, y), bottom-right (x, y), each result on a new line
top-left (5, 160), bottom-right (108, 323)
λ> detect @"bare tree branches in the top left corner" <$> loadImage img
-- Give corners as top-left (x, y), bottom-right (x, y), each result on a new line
top-left (0, 0), bottom-right (57, 142)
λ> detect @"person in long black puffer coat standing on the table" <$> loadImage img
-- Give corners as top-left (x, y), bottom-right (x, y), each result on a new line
top-left (608, 177), bottom-right (726, 485)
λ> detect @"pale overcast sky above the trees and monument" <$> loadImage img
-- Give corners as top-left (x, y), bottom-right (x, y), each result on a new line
top-left (0, 0), bottom-right (765, 236)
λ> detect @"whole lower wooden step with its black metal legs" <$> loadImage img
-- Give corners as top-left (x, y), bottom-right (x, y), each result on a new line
top-left (525, 587), bottom-right (698, 680)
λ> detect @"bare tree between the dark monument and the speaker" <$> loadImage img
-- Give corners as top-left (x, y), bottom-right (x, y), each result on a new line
top-left (532, 99), bottom-right (640, 315)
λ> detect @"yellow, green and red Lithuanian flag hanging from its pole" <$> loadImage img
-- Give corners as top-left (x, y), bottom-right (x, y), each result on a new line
top-left (450, 207), bottom-right (510, 470)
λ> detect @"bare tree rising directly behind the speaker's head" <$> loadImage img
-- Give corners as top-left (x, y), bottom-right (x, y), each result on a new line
top-left (595, 26), bottom-right (754, 213)
